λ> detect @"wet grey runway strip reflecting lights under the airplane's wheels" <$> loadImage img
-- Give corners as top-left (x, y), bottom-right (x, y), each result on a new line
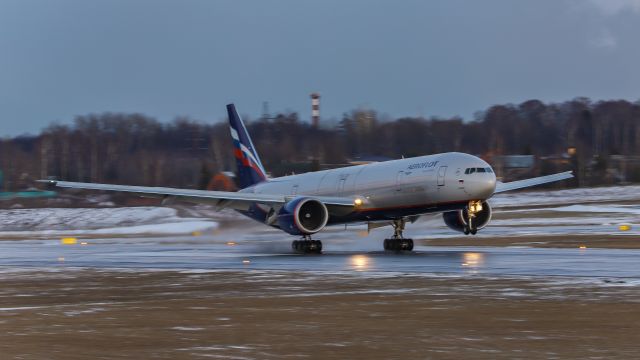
top-left (0, 233), bottom-right (640, 282)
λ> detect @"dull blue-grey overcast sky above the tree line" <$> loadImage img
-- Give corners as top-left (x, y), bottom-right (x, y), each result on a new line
top-left (0, 0), bottom-right (640, 136)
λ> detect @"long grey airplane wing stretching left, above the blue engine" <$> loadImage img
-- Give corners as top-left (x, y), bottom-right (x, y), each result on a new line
top-left (38, 180), bottom-right (355, 212)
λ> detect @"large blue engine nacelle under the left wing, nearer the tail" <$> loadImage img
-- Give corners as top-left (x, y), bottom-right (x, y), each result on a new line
top-left (278, 197), bottom-right (329, 235)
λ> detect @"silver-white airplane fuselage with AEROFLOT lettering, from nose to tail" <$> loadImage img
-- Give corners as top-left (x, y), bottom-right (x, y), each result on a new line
top-left (242, 153), bottom-right (496, 220)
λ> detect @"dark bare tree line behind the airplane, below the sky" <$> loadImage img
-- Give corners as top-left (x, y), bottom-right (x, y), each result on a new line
top-left (0, 98), bottom-right (640, 191)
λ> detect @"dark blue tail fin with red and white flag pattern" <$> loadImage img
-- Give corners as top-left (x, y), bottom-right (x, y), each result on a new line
top-left (227, 104), bottom-right (267, 189)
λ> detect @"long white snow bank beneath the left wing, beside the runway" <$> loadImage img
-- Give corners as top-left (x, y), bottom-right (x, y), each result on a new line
top-left (0, 207), bottom-right (218, 236)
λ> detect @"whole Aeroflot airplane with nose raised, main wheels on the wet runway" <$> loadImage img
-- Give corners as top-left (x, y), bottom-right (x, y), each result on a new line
top-left (40, 104), bottom-right (573, 253)
